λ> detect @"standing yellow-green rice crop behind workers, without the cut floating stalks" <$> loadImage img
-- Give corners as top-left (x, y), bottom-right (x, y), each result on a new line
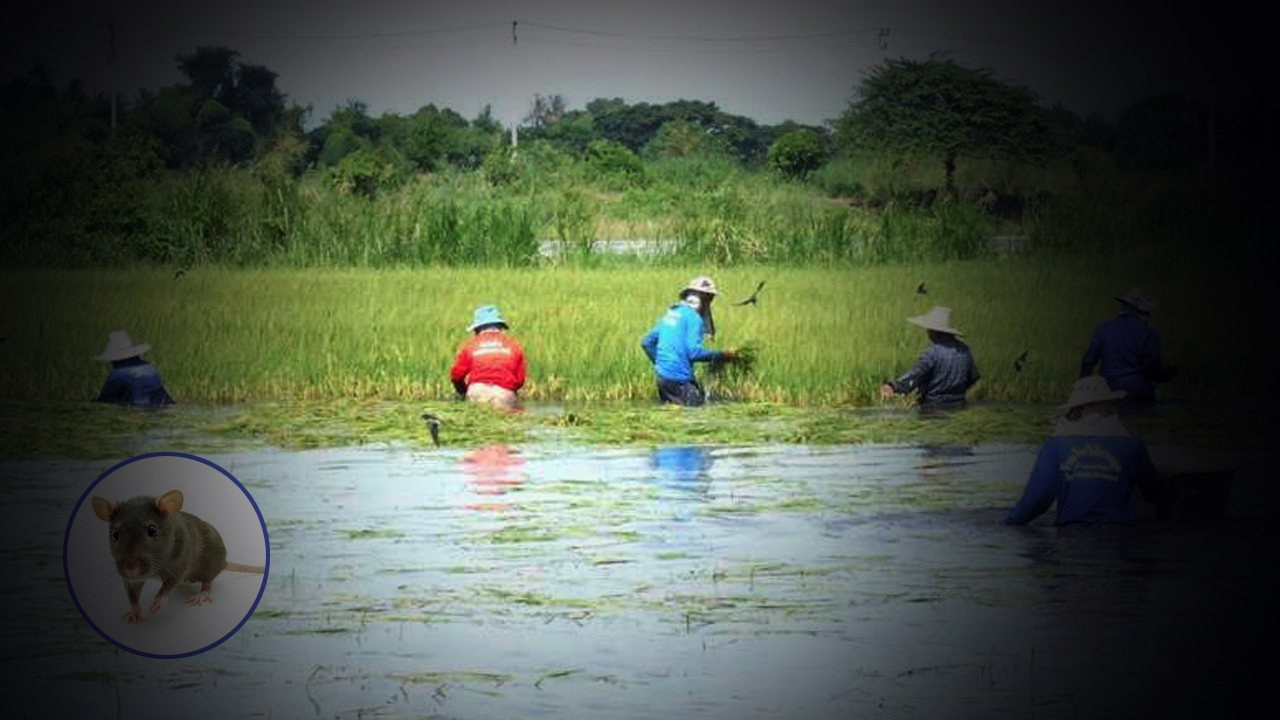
top-left (0, 258), bottom-right (1272, 405)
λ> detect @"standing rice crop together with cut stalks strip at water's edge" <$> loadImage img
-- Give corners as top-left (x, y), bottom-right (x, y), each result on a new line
top-left (0, 249), bottom-right (1272, 455)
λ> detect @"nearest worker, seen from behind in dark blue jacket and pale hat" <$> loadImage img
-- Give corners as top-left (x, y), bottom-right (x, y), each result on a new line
top-left (1004, 375), bottom-right (1169, 525)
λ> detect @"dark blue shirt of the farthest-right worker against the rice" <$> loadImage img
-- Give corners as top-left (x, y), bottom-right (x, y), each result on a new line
top-left (1080, 311), bottom-right (1166, 402)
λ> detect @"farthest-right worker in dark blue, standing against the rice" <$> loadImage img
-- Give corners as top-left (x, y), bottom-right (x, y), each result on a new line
top-left (1080, 287), bottom-right (1178, 405)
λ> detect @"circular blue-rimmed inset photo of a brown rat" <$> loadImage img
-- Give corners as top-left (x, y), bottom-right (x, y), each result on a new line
top-left (63, 452), bottom-right (270, 657)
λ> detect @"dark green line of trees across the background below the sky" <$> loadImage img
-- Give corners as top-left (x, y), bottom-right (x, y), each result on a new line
top-left (0, 46), bottom-right (1277, 266)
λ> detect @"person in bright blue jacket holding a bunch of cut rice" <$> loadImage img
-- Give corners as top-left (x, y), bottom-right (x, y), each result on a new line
top-left (640, 277), bottom-right (737, 406)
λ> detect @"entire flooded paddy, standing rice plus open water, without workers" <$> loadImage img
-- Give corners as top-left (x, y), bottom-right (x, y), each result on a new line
top-left (0, 255), bottom-right (1280, 720)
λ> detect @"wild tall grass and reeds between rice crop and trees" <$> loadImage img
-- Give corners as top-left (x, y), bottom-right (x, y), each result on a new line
top-left (0, 145), bottom-right (1265, 268)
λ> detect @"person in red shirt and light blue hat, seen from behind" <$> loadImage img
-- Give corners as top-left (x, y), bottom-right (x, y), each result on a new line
top-left (449, 305), bottom-right (526, 410)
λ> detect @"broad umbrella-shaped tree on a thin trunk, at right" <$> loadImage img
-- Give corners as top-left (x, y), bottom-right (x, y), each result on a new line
top-left (836, 56), bottom-right (1052, 196)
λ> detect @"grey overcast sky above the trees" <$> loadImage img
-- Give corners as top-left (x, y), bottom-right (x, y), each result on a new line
top-left (0, 0), bottom-right (1265, 124)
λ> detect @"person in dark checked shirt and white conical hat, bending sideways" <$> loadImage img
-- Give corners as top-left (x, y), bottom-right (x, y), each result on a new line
top-left (881, 305), bottom-right (982, 410)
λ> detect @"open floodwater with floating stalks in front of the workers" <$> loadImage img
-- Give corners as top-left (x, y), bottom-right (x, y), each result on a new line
top-left (0, 445), bottom-right (1275, 719)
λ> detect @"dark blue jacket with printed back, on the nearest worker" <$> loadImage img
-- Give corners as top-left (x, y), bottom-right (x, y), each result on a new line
top-left (1005, 427), bottom-right (1165, 525)
